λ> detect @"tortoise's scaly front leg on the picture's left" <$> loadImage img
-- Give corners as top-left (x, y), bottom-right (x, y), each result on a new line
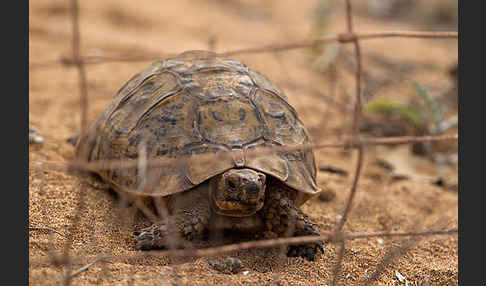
top-left (135, 184), bottom-right (211, 249)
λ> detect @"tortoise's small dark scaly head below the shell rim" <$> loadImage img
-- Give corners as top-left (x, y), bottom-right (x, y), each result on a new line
top-left (210, 168), bottom-right (266, 217)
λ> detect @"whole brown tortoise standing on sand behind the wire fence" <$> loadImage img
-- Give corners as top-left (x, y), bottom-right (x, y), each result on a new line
top-left (76, 51), bottom-right (323, 261)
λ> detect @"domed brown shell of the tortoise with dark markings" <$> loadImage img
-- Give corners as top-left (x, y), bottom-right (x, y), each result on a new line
top-left (76, 51), bottom-right (320, 203)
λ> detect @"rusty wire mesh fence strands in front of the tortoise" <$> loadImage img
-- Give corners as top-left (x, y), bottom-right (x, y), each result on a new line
top-left (29, 0), bottom-right (458, 285)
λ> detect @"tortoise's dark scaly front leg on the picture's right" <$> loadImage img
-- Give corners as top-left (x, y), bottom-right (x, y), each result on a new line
top-left (263, 185), bottom-right (324, 261)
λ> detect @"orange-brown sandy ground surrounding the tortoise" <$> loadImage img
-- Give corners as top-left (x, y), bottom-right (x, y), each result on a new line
top-left (29, 0), bottom-right (458, 285)
